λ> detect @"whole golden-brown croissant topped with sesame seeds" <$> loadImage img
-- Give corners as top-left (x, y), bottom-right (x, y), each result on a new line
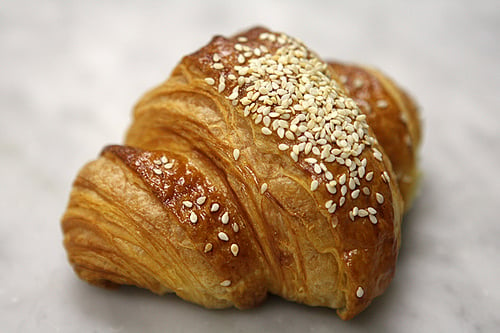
top-left (62, 27), bottom-right (420, 319)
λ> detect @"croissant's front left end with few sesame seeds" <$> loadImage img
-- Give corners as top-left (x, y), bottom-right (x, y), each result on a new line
top-left (63, 146), bottom-right (266, 308)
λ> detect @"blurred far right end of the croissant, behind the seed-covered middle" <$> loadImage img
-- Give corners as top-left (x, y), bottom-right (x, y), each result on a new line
top-left (329, 62), bottom-right (421, 211)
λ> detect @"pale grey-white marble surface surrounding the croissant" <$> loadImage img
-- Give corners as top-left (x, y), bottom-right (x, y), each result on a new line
top-left (0, 0), bottom-right (500, 332)
